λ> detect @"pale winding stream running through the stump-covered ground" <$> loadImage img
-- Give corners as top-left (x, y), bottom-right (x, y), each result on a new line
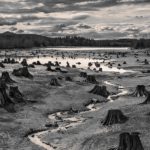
top-left (28, 81), bottom-right (129, 150)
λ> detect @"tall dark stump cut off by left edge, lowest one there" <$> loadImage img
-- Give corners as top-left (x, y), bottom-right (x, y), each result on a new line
top-left (0, 84), bottom-right (15, 112)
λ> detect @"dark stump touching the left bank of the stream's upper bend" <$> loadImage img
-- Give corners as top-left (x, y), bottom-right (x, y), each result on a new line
top-left (89, 85), bottom-right (110, 98)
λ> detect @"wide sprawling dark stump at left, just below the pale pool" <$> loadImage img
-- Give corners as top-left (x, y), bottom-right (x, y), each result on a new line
top-left (12, 67), bottom-right (33, 78)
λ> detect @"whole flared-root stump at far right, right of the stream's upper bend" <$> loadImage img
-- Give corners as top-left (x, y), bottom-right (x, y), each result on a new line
top-left (132, 85), bottom-right (148, 97)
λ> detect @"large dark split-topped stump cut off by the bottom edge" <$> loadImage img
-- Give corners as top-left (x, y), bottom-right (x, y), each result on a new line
top-left (117, 132), bottom-right (144, 150)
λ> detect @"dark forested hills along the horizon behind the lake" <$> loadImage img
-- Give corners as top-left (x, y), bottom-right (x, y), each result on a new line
top-left (0, 32), bottom-right (150, 49)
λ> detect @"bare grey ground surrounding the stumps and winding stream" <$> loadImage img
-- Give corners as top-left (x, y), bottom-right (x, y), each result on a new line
top-left (0, 50), bottom-right (150, 150)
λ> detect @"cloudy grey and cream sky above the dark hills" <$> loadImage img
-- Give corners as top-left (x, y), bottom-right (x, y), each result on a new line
top-left (0, 0), bottom-right (150, 39)
